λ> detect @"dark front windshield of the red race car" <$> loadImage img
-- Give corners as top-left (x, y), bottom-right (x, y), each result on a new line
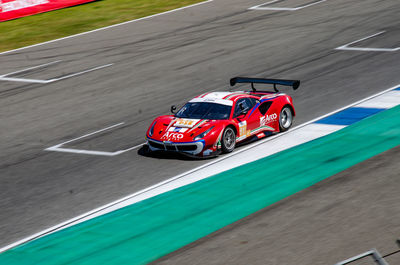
top-left (175, 102), bottom-right (232, 120)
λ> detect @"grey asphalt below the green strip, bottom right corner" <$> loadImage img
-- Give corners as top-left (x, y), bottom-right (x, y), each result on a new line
top-left (151, 147), bottom-right (400, 265)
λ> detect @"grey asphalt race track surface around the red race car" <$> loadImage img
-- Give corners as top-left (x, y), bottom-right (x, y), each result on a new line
top-left (0, 0), bottom-right (400, 246)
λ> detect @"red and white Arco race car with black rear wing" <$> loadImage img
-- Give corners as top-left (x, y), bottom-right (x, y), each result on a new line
top-left (146, 77), bottom-right (300, 157)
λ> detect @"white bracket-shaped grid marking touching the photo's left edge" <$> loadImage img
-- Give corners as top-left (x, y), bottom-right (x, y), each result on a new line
top-left (0, 60), bottom-right (113, 84)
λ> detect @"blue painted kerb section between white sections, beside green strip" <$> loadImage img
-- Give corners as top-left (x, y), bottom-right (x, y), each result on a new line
top-left (314, 107), bottom-right (385, 125)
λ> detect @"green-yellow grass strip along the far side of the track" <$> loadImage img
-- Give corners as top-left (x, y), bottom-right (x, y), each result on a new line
top-left (0, 0), bottom-right (202, 52)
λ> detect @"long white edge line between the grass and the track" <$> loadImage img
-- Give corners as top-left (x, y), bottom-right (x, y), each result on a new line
top-left (0, 0), bottom-right (214, 55)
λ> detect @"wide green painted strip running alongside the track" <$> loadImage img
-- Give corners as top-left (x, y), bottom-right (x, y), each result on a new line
top-left (0, 106), bottom-right (400, 265)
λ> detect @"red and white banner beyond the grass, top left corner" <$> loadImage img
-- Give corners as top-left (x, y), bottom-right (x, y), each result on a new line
top-left (0, 0), bottom-right (95, 21)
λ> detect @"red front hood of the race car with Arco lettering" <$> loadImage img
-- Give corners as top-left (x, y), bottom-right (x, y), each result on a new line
top-left (147, 115), bottom-right (218, 142)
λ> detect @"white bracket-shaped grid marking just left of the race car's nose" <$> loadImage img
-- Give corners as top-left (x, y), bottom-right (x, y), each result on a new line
top-left (44, 122), bottom-right (143, 156)
